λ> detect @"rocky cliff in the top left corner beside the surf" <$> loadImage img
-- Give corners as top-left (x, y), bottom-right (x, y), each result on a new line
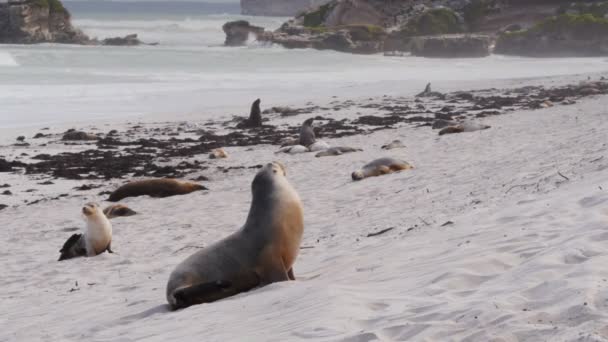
top-left (0, 0), bottom-right (90, 44)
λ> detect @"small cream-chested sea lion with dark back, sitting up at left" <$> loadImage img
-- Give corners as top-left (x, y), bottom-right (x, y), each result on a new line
top-left (59, 203), bottom-right (114, 261)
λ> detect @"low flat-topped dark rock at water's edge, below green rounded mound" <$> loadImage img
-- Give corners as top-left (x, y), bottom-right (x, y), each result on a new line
top-left (411, 35), bottom-right (492, 58)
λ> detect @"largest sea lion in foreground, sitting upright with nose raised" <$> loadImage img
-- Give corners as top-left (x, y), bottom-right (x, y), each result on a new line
top-left (167, 162), bottom-right (304, 309)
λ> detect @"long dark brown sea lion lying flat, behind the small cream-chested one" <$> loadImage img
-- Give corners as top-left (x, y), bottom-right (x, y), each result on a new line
top-left (108, 178), bottom-right (207, 202)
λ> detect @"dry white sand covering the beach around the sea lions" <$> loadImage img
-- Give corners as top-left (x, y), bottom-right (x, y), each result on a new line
top-left (0, 78), bottom-right (608, 342)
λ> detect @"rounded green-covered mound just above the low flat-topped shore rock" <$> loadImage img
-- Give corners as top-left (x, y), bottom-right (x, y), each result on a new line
top-left (402, 8), bottom-right (463, 36)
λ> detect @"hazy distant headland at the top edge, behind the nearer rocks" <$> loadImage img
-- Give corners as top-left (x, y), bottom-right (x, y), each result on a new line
top-left (241, 0), bottom-right (329, 17)
